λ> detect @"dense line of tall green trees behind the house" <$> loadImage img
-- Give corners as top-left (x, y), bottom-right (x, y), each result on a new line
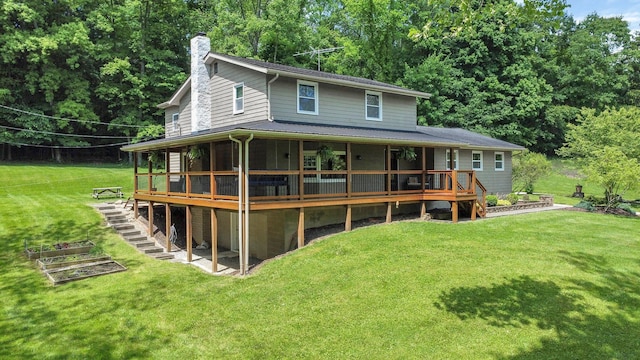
top-left (0, 0), bottom-right (640, 159)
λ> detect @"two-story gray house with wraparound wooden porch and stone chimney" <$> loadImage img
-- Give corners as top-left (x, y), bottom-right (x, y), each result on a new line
top-left (124, 34), bottom-right (524, 273)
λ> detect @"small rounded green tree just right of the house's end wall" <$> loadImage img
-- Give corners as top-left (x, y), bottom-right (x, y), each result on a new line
top-left (511, 151), bottom-right (551, 194)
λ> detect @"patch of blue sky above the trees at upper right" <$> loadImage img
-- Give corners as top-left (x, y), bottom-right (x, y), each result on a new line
top-left (565, 0), bottom-right (640, 33)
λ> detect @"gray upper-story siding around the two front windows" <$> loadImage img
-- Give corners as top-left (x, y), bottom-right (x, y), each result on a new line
top-left (271, 77), bottom-right (416, 131)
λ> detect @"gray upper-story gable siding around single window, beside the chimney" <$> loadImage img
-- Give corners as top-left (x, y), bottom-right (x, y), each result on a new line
top-left (211, 61), bottom-right (267, 127)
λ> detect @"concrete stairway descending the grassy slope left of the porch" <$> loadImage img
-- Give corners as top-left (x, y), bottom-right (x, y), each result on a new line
top-left (96, 204), bottom-right (174, 260)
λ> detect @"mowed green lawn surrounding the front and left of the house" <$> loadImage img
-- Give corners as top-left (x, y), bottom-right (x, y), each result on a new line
top-left (0, 164), bottom-right (640, 359)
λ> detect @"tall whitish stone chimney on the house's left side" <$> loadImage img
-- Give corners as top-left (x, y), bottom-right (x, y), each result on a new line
top-left (191, 33), bottom-right (211, 133)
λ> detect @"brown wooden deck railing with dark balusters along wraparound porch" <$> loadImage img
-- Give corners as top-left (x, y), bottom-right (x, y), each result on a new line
top-left (135, 170), bottom-right (477, 201)
